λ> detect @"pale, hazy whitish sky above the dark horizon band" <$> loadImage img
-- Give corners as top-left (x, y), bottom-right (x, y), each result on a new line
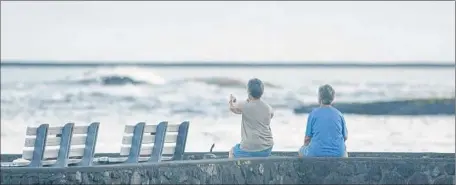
top-left (1, 1), bottom-right (455, 62)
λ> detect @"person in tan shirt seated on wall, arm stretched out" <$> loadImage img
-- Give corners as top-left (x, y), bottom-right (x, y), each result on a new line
top-left (229, 78), bottom-right (274, 158)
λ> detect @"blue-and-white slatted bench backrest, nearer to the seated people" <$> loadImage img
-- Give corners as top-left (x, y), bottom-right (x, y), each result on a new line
top-left (120, 121), bottom-right (189, 163)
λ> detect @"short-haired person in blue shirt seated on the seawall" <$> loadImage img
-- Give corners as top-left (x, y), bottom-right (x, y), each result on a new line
top-left (298, 84), bottom-right (347, 157)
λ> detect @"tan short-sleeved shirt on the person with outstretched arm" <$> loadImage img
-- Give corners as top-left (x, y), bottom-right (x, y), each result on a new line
top-left (239, 99), bottom-right (274, 152)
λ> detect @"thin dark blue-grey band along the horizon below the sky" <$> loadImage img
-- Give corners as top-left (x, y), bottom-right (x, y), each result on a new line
top-left (0, 60), bottom-right (456, 68)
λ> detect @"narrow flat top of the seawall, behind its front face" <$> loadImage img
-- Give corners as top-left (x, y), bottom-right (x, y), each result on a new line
top-left (0, 151), bottom-right (455, 162)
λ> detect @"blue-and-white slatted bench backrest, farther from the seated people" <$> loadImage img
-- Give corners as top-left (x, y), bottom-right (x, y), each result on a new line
top-left (22, 122), bottom-right (99, 167)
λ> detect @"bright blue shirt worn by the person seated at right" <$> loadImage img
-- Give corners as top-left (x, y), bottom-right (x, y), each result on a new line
top-left (306, 107), bottom-right (347, 157)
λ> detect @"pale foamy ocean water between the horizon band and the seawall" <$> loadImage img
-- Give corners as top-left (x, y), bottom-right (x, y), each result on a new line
top-left (1, 67), bottom-right (455, 153)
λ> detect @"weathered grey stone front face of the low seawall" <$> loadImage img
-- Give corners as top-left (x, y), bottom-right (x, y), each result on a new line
top-left (1, 157), bottom-right (455, 184)
